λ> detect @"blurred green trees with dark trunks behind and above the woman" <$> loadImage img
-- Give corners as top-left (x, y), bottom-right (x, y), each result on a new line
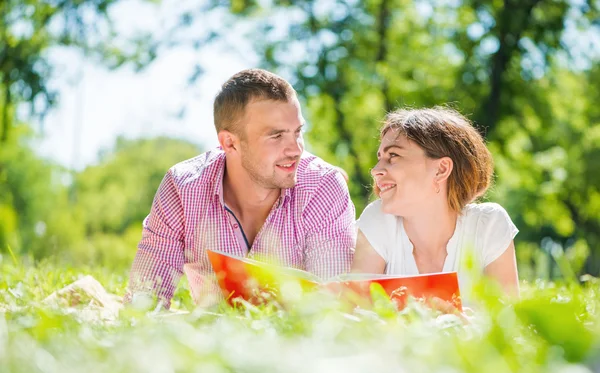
top-left (193, 0), bottom-right (600, 276)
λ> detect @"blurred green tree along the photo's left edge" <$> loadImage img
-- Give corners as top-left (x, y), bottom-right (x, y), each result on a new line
top-left (0, 0), bottom-right (155, 262)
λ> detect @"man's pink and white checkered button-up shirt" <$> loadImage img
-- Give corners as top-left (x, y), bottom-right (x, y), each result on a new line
top-left (125, 149), bottom-right (355, 307)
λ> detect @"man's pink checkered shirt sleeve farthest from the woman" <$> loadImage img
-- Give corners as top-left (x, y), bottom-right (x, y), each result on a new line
top-left (124, 171), bottom-right (185, 308)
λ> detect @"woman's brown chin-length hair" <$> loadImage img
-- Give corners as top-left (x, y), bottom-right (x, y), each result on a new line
top-left (373, 107), bottom-right (494, 213)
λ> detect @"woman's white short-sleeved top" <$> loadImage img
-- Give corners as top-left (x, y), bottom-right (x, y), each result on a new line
top-left (357, 200), bottom-right (519, 298)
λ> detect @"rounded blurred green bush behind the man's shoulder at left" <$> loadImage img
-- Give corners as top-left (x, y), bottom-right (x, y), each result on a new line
top-left (74, 137), bottom-right (200, 233)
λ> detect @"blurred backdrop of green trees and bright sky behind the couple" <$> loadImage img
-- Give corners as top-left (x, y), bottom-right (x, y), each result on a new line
top-left (0, 0), bottom-right (600, 280)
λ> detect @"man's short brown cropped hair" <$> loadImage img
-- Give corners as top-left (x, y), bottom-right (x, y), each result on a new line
top-left (213, 69), bottom-right (296, 138)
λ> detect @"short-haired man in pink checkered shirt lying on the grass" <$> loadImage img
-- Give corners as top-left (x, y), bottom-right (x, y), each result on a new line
top-left (126, 69), bottom-right (355, 308)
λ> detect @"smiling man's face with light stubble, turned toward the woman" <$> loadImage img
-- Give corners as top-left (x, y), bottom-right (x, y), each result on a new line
top-left (240, 98), bottom-right (304, 189)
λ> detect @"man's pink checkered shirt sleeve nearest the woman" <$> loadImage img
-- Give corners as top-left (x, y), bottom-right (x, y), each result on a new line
top-left (303, 172), bottom-right (356, 278)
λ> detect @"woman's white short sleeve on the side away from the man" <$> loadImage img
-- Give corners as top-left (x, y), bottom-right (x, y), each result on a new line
top-left (477, 203), bottom-right (519, 268)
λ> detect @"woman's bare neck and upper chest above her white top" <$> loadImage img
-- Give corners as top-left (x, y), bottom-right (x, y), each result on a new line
top-left (403, 201), bottom-right (458, 256)
